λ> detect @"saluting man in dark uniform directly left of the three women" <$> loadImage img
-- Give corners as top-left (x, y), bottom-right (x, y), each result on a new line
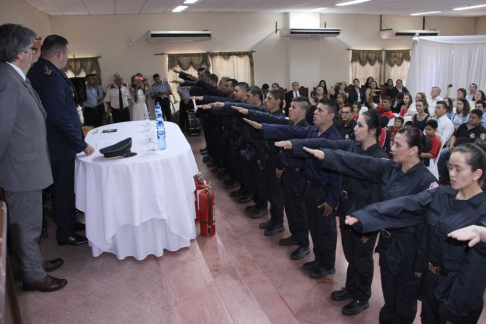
top-left (247, 100), bottom-right (341, 279)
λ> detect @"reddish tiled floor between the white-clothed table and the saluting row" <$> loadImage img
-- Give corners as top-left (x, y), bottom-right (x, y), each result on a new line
top-left (18, 130), bottom-right (486, 324)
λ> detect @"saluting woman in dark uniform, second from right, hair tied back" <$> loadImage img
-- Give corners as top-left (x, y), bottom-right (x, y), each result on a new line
top-left (304, 127), bottom-right (438, 323)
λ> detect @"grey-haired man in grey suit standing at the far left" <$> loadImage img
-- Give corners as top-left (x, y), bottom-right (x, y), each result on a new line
top-left (0, 24), bottom-right (67, 291)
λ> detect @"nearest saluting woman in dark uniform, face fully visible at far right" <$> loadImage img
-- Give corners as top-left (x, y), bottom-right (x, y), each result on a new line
top-left (346, 143), bottom-right (486, 324)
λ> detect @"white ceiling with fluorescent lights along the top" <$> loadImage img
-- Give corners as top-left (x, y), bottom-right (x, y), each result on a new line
top-left (25, 0), bottom-right (486, 17)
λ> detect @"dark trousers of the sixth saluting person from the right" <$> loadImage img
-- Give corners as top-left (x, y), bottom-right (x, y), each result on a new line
top-left (263, 154), bottom-right (284, 225)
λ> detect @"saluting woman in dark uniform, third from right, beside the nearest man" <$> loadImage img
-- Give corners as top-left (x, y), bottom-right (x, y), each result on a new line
top-left (277, 108), bottom-right (388, 315)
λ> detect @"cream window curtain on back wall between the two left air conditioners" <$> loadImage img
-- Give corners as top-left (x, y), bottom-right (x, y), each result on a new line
top-left (211, 55), bottom-right (252, 85)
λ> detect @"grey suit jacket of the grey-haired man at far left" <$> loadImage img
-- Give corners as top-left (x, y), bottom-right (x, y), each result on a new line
top-left (0, 63), bottom-right (52, 192)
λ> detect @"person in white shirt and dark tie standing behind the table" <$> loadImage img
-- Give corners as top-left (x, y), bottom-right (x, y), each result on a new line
top-left (105, 73), bottom-right (132, 123)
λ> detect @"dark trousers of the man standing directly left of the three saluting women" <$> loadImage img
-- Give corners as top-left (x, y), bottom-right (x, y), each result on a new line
top-left (305, 183), bottom-right (337, 270)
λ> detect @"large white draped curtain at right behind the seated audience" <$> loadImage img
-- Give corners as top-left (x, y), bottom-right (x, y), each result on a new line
top-left (408, 35), bottom-right (486, 95)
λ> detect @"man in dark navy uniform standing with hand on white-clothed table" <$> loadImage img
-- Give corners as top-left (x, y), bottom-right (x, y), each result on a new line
top-left (27, 35), bottom-right (94, 246)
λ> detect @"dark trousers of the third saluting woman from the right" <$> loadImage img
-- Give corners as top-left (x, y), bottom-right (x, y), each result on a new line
top-left (339, 216), bottom-right (377, 301)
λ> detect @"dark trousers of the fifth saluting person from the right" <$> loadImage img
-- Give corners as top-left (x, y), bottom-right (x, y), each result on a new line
top-left (282, 168), bottom-right (309, 248)
